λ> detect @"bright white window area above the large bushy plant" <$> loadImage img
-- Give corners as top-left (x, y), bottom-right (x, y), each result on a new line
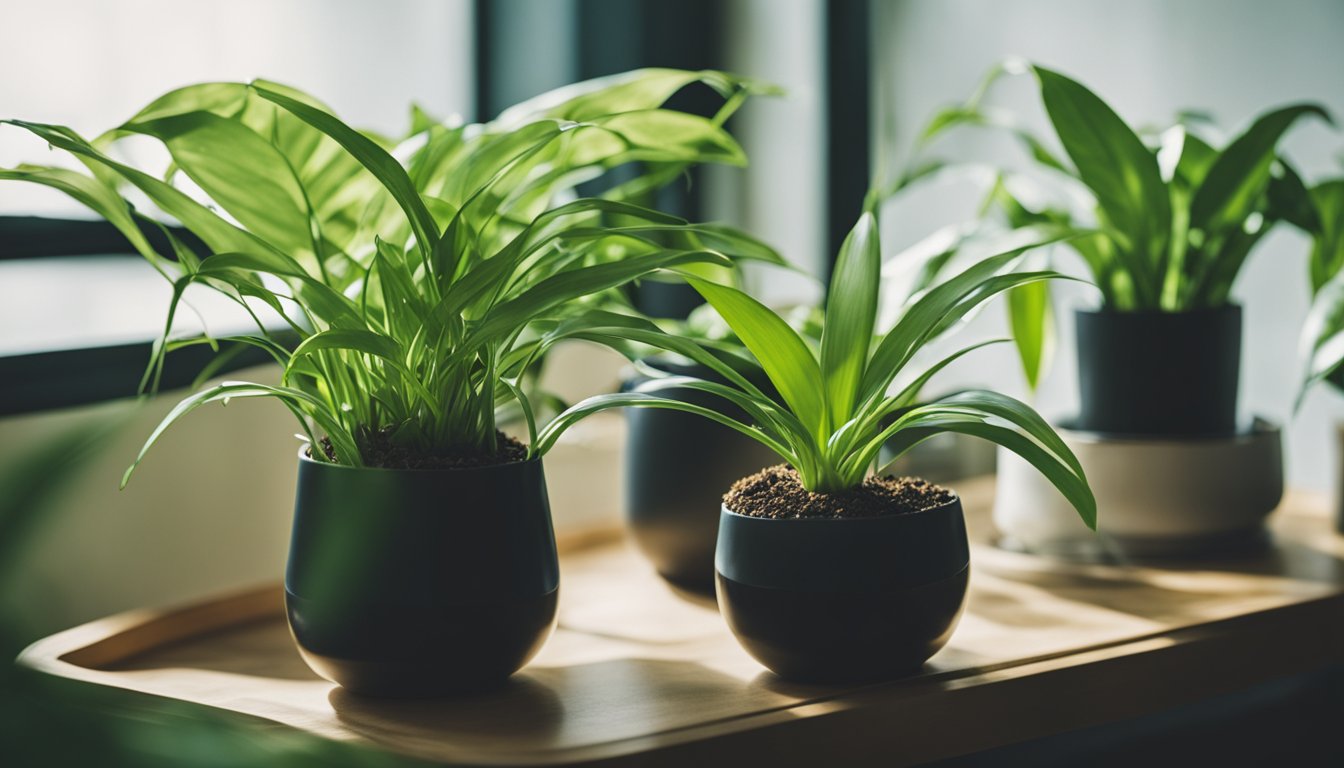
top-left (0, 0), bottom-right (476, 214)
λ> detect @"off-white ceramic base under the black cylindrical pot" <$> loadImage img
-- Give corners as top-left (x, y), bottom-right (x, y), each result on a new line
top-left (995, 420), bottom-right (1284, 557)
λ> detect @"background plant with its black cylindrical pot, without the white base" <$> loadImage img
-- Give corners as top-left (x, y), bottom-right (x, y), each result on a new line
top-left (926, 62), bottom-right (1329, 437)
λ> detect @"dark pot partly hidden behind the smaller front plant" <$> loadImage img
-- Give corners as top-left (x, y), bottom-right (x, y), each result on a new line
top-left (624, 362), bottom-right (780, 594)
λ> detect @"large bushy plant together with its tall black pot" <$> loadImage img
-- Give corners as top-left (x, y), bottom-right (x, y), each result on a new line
top-left (3, 70), bottom-right (771, 695)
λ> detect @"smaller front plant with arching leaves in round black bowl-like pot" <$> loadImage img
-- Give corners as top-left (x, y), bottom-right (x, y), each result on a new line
top-left (529, 213), bottom-right (1095, 682)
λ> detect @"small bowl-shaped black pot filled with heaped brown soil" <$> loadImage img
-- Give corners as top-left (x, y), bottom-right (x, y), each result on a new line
top-left (715, 499), bottom-right (970, 682)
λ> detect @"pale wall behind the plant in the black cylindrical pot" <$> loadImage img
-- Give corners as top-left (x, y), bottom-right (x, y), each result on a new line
top-left (874, 0), bottom-right (1344, 488)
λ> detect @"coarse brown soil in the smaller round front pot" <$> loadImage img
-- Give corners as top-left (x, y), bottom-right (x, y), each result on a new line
top-left (723, 464), bottom-right (957, 518)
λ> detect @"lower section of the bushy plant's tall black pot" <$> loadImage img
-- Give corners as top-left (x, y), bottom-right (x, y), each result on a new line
top-left (285, 589), bottom-right (559, 698)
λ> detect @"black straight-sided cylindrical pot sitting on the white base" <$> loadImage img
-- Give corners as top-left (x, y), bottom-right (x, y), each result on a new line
top-left (1074, 304), bottom-right (1242, 437)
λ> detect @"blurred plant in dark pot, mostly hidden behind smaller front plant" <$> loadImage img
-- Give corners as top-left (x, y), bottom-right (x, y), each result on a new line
top-left (624, 180), bottom-right (1016, 594)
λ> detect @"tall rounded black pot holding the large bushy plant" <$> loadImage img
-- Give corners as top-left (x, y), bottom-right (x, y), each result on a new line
top-left (285, 455), bottom-right (559, 697)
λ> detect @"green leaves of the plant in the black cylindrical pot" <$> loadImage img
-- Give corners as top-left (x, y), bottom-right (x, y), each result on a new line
top-left (919, 61), bottom-right (1331, 381)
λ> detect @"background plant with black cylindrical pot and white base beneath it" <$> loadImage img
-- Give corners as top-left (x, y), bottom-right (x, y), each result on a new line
top-left (929, 62), bottom-right (1329, 554)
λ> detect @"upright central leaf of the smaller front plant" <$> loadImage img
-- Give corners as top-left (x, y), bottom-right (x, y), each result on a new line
top-left (817, 211), bottom-right (882, 426)
